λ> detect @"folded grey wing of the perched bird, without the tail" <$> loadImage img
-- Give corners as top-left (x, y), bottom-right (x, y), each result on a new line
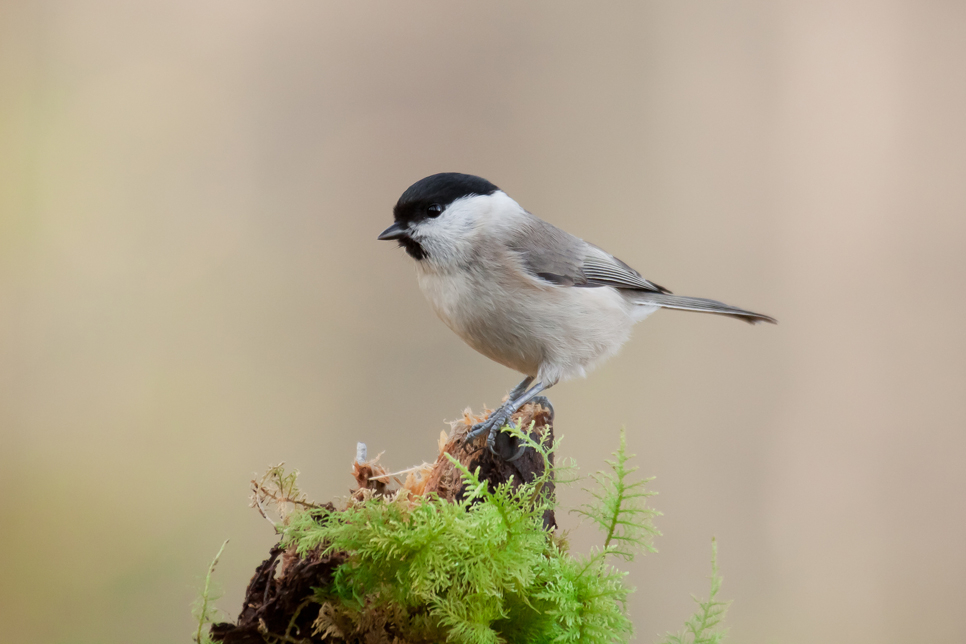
top-left (510, 215), bottom-right (670, 293)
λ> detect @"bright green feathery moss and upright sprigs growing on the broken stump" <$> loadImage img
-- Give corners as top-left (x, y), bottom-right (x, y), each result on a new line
top-left (202, 428), bottom-right (725, 644)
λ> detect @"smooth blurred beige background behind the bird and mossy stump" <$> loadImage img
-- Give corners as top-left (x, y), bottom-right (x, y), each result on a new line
top-left (0, 0), bottom-right (966, 644)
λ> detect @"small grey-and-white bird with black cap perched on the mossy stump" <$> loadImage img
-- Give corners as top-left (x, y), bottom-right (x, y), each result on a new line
top-left (378, 172), bottom-right (776, 460)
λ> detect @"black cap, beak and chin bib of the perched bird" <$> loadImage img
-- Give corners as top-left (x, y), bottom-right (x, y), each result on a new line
top-left (378, 172), bottom-right (499, 259)
